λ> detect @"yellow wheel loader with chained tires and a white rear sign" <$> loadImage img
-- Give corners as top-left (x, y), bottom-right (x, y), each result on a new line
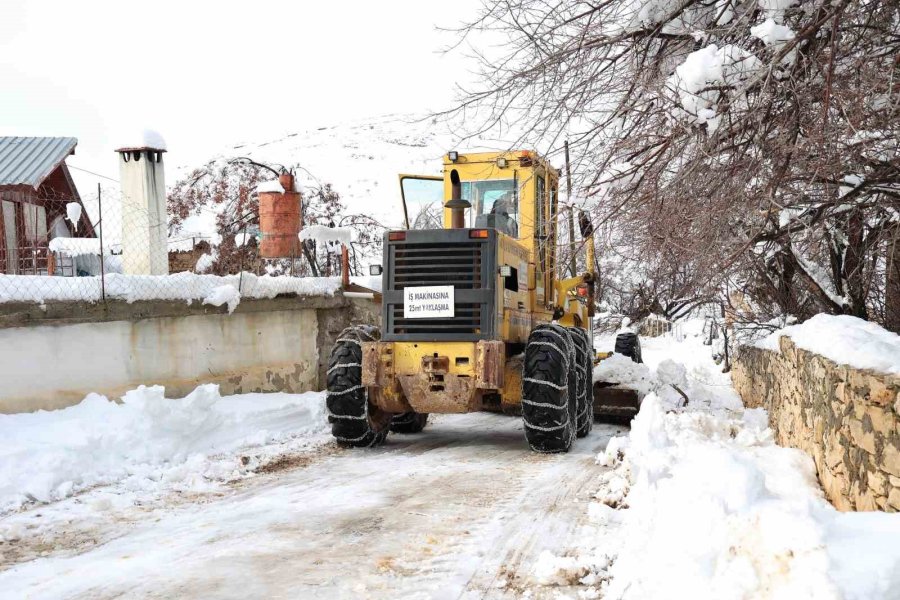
top-left (327, 151), bottom-right (636, 452)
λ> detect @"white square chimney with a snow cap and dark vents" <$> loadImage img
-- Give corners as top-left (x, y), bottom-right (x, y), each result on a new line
top-left (116, 131), bottom-right (169, 275)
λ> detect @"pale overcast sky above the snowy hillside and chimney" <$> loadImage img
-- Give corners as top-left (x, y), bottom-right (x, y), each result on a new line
top-left (0, 0), bottom-right (479, 184)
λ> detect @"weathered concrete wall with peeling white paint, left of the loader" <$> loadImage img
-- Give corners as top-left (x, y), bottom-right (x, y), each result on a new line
top-left (0, 297), bottom-right (377, 413)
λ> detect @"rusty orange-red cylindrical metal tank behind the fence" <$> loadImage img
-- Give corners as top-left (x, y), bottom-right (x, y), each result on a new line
top-left (259, 173), bottom-right (301, 258)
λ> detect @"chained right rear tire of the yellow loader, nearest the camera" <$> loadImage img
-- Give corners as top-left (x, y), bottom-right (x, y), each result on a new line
top-left (522, 325), bottom-right (577, 453)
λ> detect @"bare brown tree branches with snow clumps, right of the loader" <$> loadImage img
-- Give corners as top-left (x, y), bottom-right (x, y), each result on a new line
top-left (453, 0), bottom-right (900, 322)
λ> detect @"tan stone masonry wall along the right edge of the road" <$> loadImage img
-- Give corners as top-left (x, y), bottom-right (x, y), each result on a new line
top-left (732, 337), bottom-right (900, 512)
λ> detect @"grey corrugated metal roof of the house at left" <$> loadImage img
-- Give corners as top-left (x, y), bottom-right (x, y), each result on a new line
top-left (0, 137), bottom-right (78, 189)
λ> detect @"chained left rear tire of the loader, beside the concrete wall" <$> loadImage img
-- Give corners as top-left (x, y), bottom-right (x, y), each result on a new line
top-left (325, 325), bottom-right (391, 448)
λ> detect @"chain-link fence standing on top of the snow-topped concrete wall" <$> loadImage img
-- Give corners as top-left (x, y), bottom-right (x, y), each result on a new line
top-left (0, 187), bottom-right (352, 307)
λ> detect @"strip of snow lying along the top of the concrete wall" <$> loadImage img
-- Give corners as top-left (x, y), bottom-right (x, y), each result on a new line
top-left (0, 274), bottom-right (341, 303)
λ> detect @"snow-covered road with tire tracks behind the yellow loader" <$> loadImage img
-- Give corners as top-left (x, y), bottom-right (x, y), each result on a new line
top-left (0, 414), bottom-right (622, 599)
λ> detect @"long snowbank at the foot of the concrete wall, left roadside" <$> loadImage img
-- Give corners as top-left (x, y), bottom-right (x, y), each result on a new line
top-left (0, 385), bottom-right (326, 513)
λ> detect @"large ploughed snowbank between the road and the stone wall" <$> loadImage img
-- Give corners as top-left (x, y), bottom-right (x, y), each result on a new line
top-left (533, 322), bottom-right (900, 600)
